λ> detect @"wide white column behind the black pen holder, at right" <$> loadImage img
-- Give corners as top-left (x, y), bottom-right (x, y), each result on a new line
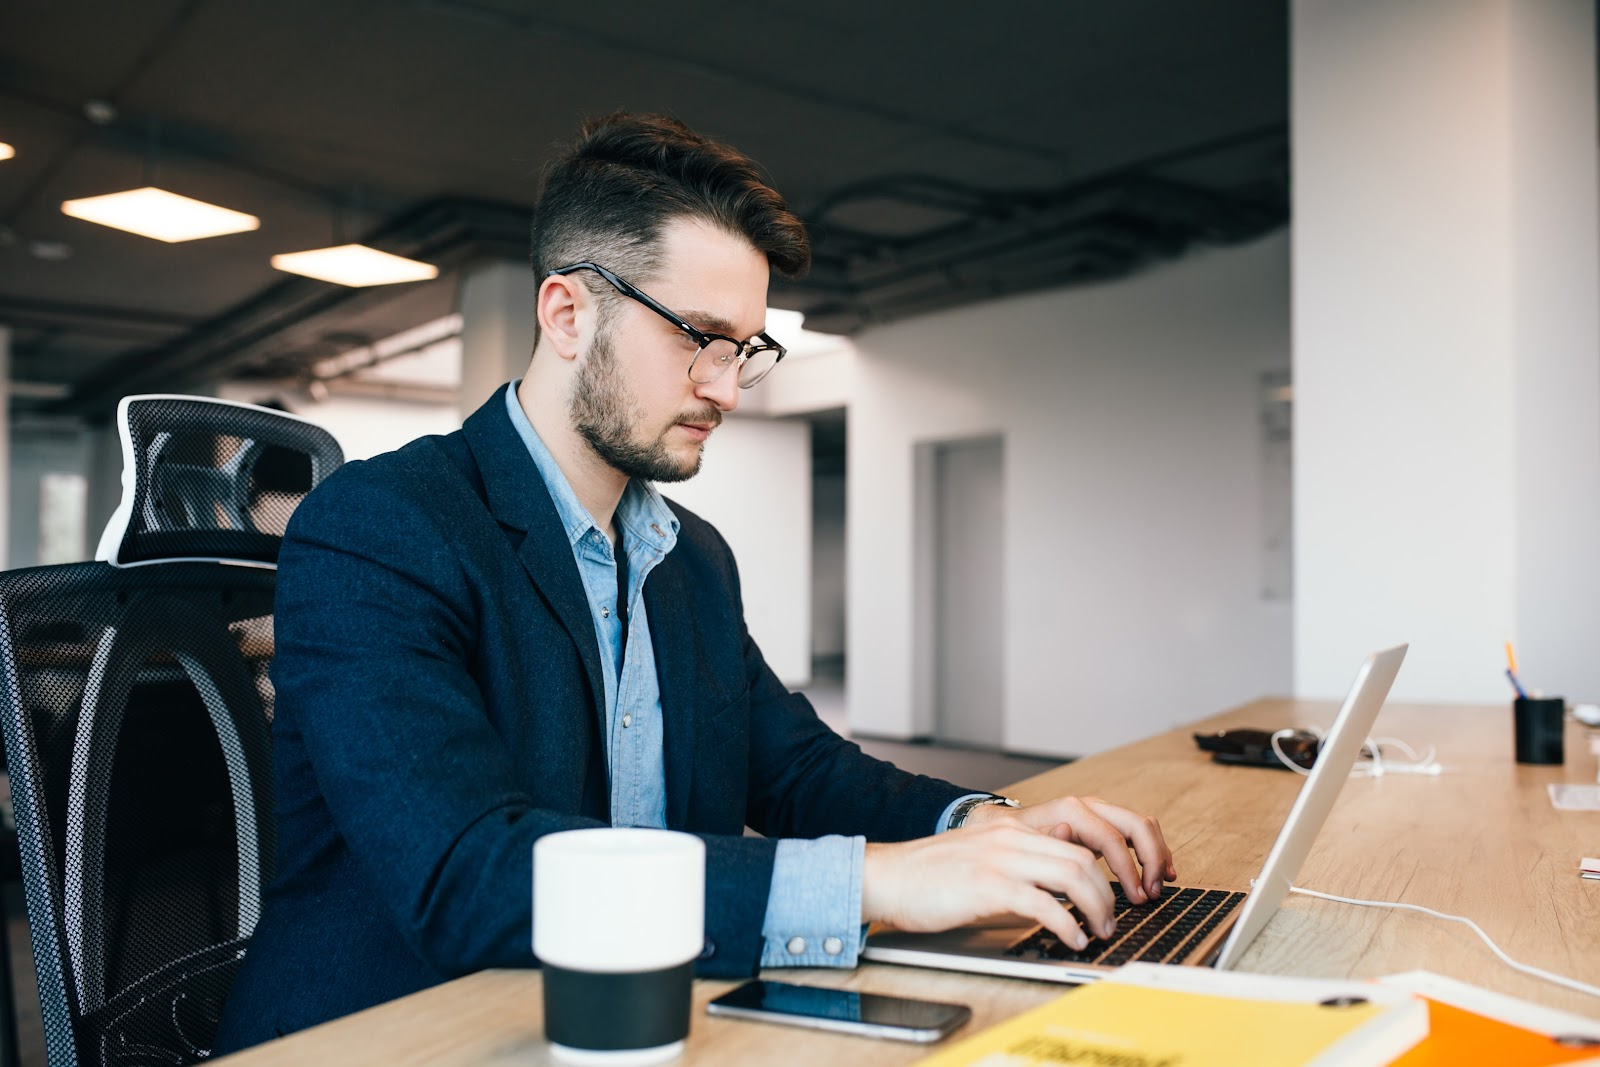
top-left (1291, 0), bottom-right (1600, 702)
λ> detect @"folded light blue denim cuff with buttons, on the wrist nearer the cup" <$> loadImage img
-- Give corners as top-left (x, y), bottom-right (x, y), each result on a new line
top-left (762, 837), bottom-right (867, 968)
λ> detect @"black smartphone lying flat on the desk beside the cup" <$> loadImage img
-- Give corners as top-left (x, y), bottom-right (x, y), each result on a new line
top-left (706, 979), bottom-right (973, 1043)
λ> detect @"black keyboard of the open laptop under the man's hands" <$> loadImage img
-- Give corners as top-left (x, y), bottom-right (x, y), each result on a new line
top-left (1006, 881), bottom-right (1246, 966)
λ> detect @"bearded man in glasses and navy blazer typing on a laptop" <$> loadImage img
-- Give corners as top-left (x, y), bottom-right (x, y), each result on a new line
top-left (219, 115), bottom-right (1174, 1048)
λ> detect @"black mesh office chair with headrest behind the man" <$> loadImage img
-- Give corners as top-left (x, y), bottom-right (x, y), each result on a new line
top-left (0, 397), bottom-right (342, 1067)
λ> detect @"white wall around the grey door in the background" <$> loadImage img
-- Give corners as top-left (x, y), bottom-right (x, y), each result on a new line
top-left (848, 234), bottom-right (1291, 755)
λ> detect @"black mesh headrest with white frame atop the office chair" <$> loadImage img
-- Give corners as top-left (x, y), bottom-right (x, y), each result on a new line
top-left (94, 394), bottom-right (344, 566)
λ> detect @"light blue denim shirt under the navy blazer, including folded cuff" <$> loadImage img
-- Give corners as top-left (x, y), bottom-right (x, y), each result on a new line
top-left (506, 382), bottom-right (870, 966)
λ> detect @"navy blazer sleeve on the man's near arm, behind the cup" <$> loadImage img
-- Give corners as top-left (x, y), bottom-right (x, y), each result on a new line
top-left (274, 464), bottom-right (776, 974)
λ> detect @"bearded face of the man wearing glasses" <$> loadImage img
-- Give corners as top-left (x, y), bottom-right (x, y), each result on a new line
top-left (568, 219), bottom-right (768, 482)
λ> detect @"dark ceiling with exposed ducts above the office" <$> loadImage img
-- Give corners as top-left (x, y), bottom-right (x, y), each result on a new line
top-left (0, 0), bottom-right (1288, 419)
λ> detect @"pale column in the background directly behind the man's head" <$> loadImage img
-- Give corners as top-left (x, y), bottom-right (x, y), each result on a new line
top-left (459, 261), bottom-right (538, 418)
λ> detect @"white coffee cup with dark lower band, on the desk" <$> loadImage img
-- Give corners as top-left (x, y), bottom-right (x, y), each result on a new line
top-left (533, 829), bottom-right (706, 1067)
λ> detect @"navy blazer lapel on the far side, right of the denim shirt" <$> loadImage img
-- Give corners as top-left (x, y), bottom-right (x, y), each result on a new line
top-left (645, 553), bottom-right (694, 829)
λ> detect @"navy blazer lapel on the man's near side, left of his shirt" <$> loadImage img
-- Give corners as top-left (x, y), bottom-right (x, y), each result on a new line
top-left (461, 389), bottom-right (605, 726)
